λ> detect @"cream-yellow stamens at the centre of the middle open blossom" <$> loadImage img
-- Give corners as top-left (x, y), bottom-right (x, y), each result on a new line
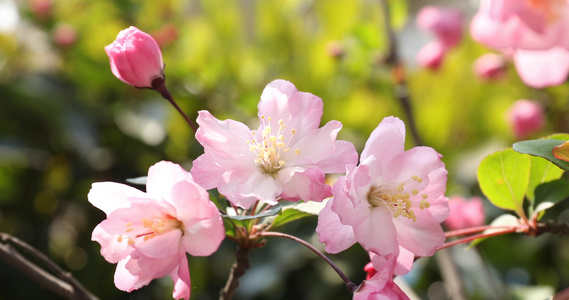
top-left (247, 116), bottom-right (300, 175)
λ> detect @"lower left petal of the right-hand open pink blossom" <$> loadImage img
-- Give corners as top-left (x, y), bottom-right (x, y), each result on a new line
top-left (316, 199), bottom-right (356, 254)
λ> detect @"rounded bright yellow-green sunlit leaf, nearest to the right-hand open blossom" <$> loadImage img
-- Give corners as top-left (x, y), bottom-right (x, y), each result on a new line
top-left (477, 148), bottom-right (531, 216)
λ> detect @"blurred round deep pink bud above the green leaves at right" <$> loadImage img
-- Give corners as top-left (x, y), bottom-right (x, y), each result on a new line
top-left (508, 99), bottom-right (545, 139)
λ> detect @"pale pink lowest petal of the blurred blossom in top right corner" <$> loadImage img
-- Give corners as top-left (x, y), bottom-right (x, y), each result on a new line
top-left (514, 46), bottom-right (569, 88)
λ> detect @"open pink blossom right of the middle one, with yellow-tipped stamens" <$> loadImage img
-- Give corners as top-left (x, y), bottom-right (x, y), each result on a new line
top-left (316, 117), bottom-right (449, 256)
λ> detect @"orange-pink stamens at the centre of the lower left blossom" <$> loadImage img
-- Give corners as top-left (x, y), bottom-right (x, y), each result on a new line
top-left (117, 215), bottom-right (184, 246)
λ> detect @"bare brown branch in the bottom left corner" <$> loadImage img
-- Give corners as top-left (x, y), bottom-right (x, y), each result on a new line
top-left (0, 232), bottom-right (98, 300)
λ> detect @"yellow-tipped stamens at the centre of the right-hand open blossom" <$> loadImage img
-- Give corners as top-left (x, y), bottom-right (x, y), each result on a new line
top-left (367, 176), bottom-right (431, 221)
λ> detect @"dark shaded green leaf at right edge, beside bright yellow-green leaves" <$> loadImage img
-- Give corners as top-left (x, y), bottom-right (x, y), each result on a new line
top-left (534, 179), bottom-right (569, 220)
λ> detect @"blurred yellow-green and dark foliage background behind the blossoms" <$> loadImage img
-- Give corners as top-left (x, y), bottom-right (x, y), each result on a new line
top-left (0, 0), bottom-right (569, 299)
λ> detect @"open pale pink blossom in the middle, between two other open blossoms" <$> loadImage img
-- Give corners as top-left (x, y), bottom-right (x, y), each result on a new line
top-left (191, 80), bottom-right (358, 208)
